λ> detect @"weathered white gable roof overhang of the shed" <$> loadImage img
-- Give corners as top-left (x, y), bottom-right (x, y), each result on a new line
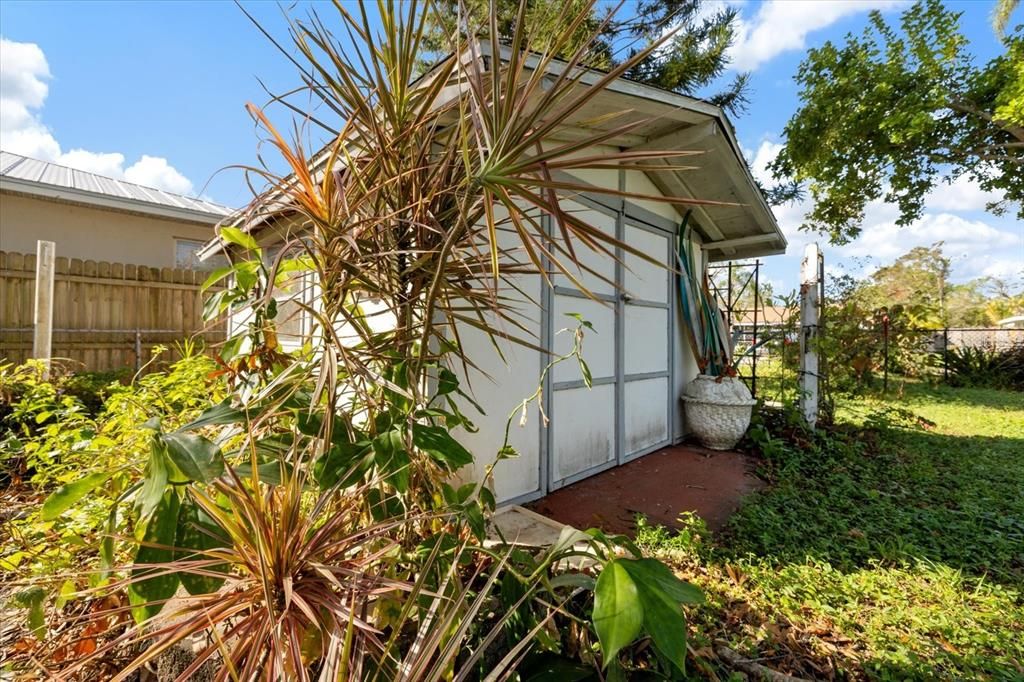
top-left (201, 41), bottom-right (786, 261)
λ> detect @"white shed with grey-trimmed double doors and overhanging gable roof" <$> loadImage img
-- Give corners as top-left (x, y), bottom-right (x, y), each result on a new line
top-left (207, 46), bottom-right (785, 503)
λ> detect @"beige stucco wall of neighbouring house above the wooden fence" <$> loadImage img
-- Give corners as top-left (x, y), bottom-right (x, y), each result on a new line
top-left (0, 193), bottom-right (213, 267)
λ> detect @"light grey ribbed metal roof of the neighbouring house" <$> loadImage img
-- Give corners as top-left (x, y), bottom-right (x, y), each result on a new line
top-left (0, 152), bottom-right (232, 224)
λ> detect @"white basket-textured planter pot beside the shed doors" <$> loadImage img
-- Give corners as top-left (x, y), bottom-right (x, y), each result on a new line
top-left (682, 374), bottom-right (757, 450)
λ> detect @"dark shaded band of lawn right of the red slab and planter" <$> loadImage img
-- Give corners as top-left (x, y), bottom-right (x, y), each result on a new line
top-left (722, 431), bottom-right (1024, 585)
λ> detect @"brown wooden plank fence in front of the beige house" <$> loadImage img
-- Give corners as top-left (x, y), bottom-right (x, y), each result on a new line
top-left (0, 251), bottom-right (224, 372)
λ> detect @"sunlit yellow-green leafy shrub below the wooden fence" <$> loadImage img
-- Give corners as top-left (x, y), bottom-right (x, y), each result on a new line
top-left (0, 348), bottom-right (223, 578)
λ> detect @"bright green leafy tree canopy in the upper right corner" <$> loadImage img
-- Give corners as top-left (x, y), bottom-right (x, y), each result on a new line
top-left (771, 0), bottom-right (1024, 244)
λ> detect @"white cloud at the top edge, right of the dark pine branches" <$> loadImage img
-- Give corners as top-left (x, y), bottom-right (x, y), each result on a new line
top-left (729, 0), bottom-right (905, 71)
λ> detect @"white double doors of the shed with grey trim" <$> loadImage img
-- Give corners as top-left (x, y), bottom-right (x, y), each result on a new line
top-left (547, 207), bottom-right (673, 489)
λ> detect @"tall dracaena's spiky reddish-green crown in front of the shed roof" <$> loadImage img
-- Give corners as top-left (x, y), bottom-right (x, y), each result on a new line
top-left (221, 1), bottom-right (720, 446)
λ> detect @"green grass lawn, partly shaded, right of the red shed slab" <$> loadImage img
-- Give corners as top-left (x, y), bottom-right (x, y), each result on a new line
top-left (638, 384), bottom-right (1024, 680)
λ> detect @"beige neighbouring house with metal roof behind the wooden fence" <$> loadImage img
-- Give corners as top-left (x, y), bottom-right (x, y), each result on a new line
top-left (0, 152), bottom-right (230, 269)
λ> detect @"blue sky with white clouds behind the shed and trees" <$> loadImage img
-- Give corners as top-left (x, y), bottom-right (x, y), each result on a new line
top-left (0, 0), bottom-right (1024, 291)
